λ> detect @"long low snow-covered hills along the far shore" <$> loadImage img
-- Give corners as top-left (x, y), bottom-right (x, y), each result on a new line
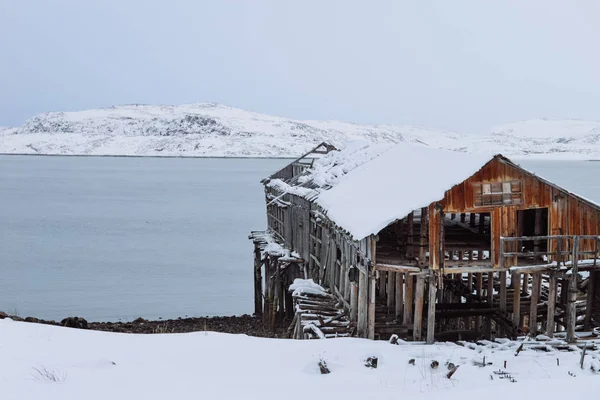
top-left (0, 103), bottom-right (600, 159)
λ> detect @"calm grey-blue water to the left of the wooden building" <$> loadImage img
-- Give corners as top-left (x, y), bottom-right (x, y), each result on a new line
top-left (0, 156), bottom-right (287, 321)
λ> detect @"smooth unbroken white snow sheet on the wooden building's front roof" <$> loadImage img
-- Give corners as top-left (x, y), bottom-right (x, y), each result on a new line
top-left (316, 144), bottom-right (493, 239)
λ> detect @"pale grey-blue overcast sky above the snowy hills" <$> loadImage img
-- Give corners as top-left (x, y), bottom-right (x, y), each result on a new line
top-left (0, 0), bottom-right (600, 132)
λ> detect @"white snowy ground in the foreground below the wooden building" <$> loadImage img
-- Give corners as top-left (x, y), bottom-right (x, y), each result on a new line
top-left (0, 319), bottom-right (600, 400)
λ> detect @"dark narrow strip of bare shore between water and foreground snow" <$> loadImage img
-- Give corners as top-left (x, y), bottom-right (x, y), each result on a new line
top-left (0, 311), bottom-right (285, 338)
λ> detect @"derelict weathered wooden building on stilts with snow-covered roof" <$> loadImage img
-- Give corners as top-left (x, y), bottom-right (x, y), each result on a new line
top-left (250, 143), bottom-right (600, 343)
